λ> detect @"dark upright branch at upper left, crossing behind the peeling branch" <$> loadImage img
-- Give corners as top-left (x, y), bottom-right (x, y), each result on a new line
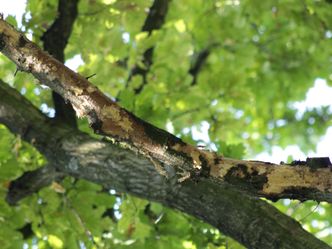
top-left (41, 0), bottom-right (79, 127)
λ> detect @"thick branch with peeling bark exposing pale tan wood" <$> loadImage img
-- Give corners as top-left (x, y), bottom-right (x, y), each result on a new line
top-left (0, 20), bottom-right (332, 202)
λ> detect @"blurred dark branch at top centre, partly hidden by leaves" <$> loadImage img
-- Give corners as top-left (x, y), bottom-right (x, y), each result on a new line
top-left (128, 0), bottom-right (169, 94)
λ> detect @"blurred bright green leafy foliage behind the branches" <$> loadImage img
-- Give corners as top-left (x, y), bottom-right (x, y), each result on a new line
top-left (0, 0), bottom-right (332, 249)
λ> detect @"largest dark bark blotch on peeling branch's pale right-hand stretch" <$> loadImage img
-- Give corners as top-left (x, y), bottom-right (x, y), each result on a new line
top-left (224, 164), bottom-right (268, 190)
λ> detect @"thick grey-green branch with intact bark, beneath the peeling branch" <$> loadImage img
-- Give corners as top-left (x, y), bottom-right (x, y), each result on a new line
top-left (0, 80), bottom-right (330, 249)
